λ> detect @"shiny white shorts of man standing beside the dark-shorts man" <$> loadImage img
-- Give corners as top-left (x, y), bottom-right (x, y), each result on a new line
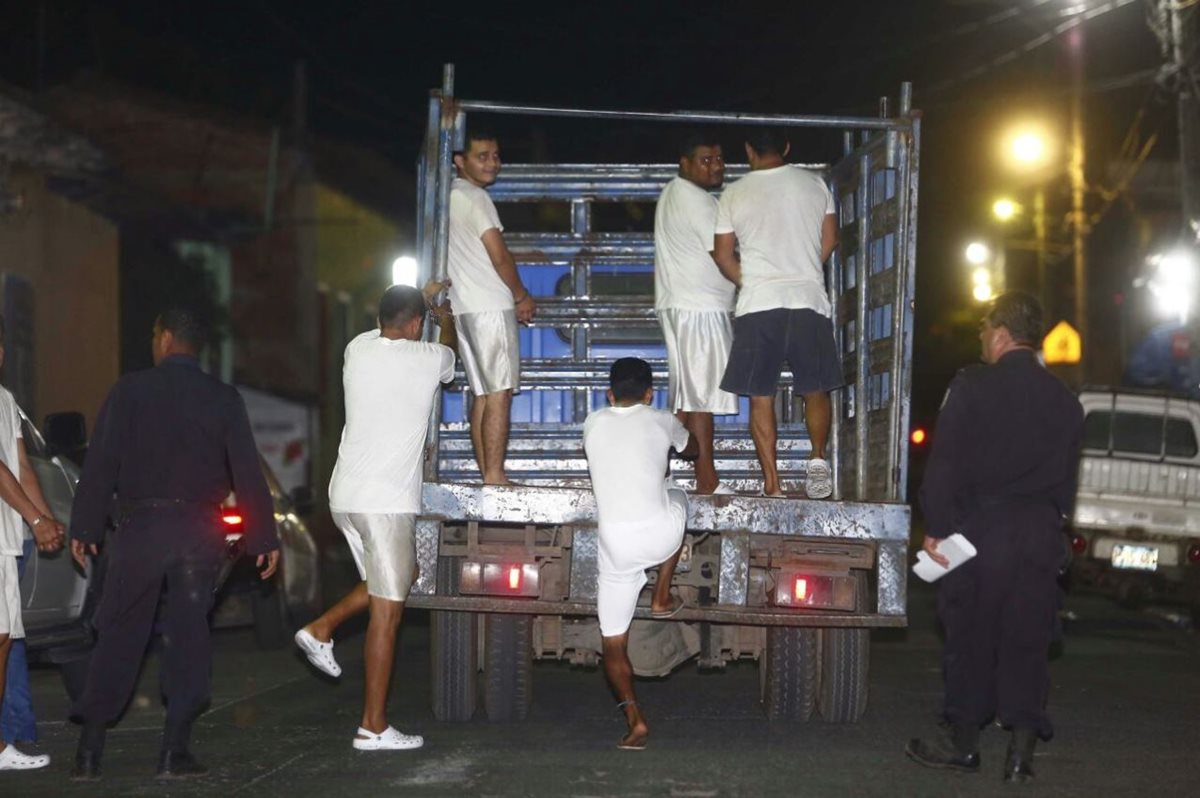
top-left (659, 308), bottom-right (738, 415)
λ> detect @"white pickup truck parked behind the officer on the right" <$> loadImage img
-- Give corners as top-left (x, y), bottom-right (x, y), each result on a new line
top-left (1072, 388), bottom-right (1200, 610)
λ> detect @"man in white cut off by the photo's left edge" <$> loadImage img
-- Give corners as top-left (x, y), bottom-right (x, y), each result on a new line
top-left (0, 318), bottom-right (64, 770)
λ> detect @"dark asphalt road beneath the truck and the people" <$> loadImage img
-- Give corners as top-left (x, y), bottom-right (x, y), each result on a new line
top-left (0, 568), bottom-right (1200, 798)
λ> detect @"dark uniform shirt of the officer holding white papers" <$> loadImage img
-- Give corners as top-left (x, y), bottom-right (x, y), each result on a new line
top-left (920, 349), bottom-right (1084, 538)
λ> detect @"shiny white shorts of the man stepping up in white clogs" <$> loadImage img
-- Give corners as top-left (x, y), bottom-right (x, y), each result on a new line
top-left (332, 512), bottom-right (416, 601)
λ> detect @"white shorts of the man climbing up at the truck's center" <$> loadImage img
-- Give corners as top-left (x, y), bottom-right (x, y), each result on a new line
top-left (596, 487), bottom-right (688, 637)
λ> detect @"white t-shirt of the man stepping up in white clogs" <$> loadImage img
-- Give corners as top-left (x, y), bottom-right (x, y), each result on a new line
top-left (329, 330), bottom-right (454, 512)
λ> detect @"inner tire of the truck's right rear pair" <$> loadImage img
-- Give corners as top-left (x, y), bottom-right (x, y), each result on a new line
top-left (758, 626), bottom-right (818, 721)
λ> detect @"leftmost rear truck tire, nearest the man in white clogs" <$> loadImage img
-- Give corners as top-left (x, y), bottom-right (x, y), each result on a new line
top-left (430, 557), bottom-right (479, 722)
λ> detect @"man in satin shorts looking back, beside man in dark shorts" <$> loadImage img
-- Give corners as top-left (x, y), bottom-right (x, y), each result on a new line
top-left (654, 133), bottom-right (738, 493)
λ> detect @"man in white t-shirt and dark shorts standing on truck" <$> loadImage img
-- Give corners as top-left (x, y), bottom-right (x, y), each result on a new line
top-left (713, 127), bottom-right (844, 499)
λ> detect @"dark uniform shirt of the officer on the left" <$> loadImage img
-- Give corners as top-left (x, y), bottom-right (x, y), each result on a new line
top-left (71, 355), bottom-right (280, 554)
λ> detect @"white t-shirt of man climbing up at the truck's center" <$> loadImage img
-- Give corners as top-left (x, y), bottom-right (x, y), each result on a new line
top-left (583, 404), bottom-right (688, 533)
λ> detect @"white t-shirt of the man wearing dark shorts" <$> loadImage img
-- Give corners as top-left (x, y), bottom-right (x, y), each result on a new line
top-left (716, 164), bottom-right (835, 316)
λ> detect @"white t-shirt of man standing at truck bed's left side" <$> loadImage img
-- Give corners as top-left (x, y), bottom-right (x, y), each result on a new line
top-left (446, 178), bottom-right (514, 313)
